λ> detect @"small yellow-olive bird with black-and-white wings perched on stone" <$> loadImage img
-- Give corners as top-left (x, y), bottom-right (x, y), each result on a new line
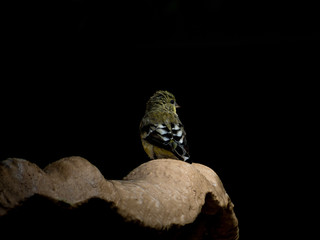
top-left (139, 90), bottom-right (190, 162)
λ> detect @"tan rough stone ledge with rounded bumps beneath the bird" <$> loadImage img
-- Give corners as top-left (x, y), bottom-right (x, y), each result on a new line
top-left (0, 157), bottom-right (238, 239)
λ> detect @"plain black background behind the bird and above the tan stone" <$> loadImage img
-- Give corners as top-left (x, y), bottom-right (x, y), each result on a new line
top-left (0, 0), bottom-right (319, 239)
